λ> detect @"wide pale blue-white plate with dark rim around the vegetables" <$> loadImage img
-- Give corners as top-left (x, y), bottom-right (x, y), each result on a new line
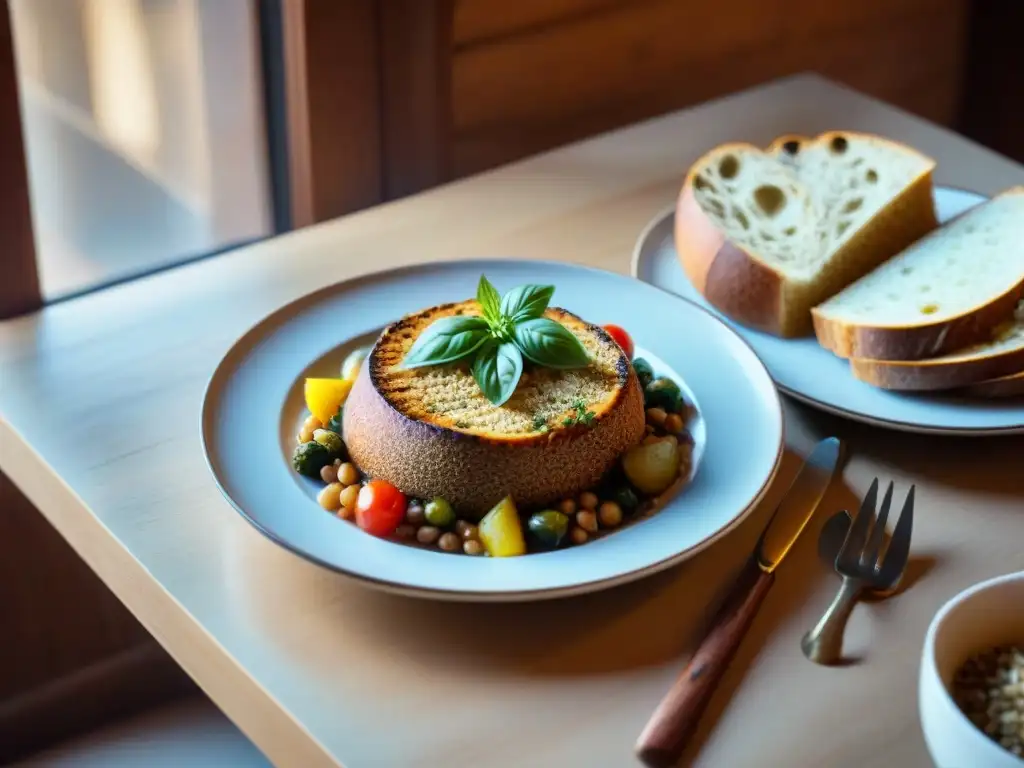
top-left (203, 261), bottom-right (783, 600)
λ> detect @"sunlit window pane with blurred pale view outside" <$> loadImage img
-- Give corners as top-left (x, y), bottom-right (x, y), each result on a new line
top-left (10, 0), bottom-right (272, 299)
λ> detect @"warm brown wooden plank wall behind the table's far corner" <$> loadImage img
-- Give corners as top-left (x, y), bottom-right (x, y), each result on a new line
top-left (452, 0), bottom-right (969, 176)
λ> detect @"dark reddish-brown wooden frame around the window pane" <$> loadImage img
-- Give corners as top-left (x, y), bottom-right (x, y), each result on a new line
top-left (0, 0), bottom-right (455, 319)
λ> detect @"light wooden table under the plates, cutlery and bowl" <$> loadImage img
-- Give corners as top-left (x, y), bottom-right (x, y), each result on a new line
top-left (0, 76), bottom-right (1024, 768)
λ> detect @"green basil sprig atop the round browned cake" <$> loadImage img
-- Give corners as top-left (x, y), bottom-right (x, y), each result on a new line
top-left (403, 274), bottom-right (590, 406)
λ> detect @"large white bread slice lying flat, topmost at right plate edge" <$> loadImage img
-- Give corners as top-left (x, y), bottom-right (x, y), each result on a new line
top-left (812, 186), bottom-right (1024, 360)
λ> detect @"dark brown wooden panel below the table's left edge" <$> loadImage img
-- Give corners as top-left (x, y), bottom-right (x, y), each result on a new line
top-left (0, 473), bottom-right (195, 765)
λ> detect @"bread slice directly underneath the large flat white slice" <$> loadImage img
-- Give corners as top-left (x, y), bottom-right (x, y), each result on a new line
top-left (850, 304), bottom-right (1024, 390)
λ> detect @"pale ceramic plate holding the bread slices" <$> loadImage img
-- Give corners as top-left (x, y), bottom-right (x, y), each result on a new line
top-left (633, 187), bottom-right (1024, 435)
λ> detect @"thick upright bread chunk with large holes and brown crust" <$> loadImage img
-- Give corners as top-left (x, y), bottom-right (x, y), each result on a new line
top-left (675, 131), bottom-right (938, 337)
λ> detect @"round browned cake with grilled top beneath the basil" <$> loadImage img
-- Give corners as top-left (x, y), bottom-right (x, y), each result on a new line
top-left (343, 301), bottom-right (645, 516)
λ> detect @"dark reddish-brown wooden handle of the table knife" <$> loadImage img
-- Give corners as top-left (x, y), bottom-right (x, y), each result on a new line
top-left (635, 560), bottom-right (775, 768)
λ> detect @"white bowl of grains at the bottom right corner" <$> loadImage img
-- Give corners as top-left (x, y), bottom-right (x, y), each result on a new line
top-left (919, 571), bottom-right (1024, 768)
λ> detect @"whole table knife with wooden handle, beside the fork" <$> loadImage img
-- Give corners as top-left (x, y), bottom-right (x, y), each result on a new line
top-left (635, 437), bottom-right (842, 768)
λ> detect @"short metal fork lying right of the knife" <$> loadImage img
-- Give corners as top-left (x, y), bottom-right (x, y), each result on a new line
top-left (800, 477), bottom-right (914, 665)
